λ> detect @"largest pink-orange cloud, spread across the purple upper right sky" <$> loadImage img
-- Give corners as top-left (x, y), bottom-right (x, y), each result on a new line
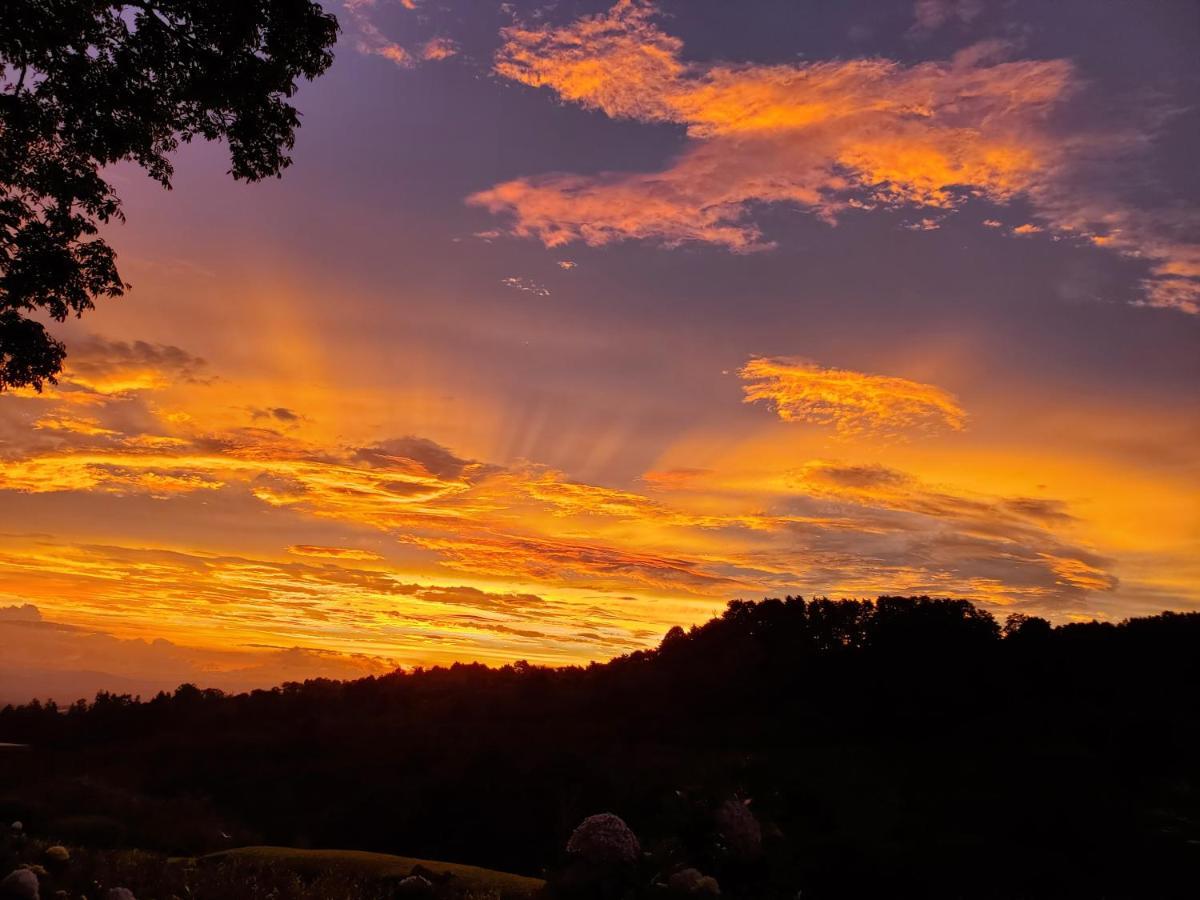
top-left (468, 0), bottom-right (1200, 312)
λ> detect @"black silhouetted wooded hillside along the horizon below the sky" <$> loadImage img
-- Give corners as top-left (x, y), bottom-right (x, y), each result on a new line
top-left (0, 598), bottom-right (1200, 898)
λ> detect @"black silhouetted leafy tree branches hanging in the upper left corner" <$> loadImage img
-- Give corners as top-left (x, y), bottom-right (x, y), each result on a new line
top-left (0, 0), bottom-right (337, 391)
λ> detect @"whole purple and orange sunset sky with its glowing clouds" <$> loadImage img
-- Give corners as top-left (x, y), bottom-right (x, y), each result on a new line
top-left (0, 0), bottom-right (1200, 702)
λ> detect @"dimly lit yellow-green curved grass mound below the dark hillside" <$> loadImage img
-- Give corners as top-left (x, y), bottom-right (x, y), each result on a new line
top-left (202, 847), bottom-right (545, 900)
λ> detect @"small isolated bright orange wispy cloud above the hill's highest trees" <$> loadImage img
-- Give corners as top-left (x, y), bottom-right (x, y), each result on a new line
top-left (738, 358), bottom-right (966, 436)
